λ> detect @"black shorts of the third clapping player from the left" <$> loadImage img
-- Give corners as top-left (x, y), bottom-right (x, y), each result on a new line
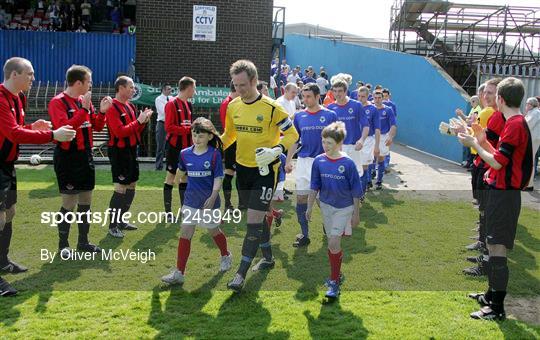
top-left (109, 146), bottom-right (139, 184)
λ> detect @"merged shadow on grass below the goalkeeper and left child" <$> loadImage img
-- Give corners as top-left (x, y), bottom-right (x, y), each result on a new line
top-left (148, 272), bottom-right (289, 339)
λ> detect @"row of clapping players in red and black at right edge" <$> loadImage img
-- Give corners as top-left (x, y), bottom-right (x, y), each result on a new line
top-left (442, 77), bottom-right (533, 320)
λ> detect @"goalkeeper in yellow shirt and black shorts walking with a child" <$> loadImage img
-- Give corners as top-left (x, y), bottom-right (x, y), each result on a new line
top-left (221, 60), bottom-right (298, 292)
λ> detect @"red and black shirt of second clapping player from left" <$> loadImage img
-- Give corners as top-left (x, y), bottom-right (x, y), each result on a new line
top-left (49, 92), bottom-right (105, 150)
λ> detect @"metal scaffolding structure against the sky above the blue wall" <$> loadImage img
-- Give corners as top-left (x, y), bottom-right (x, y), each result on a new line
top-left (389, 0), bottom-right (540, 93)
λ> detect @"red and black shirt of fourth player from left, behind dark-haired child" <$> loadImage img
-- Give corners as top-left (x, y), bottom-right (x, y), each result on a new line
top-left (165, 97), bottom-right (193, 149)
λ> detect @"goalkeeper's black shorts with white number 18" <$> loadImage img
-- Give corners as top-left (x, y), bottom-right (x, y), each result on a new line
top-left (236, 159), bottom-right (280, 211)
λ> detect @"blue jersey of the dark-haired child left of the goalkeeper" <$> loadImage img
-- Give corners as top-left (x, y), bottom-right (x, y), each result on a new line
top-left (178, 146), bottom-right (223, 209)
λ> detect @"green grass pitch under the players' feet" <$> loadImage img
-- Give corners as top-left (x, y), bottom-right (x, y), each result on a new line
top-left (0, 168), bottom-right (540, 339)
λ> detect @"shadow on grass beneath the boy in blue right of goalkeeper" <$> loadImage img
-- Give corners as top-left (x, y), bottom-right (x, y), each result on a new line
top-left (304, 300), bottom-right (369, 339)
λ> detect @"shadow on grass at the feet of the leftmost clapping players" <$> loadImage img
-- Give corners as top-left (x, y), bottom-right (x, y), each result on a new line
top-left (0, 255), bottom-right (111, 326)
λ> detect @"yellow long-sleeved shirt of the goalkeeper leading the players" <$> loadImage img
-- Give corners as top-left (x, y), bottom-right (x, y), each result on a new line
top-left (221, 95), bottom-right (298, 168)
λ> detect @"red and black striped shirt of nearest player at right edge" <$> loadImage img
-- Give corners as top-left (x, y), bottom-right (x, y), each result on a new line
top-left (484, 115), bottom-right (533, 190)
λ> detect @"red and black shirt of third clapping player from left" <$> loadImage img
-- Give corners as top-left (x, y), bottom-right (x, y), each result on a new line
top-left (106, 98), bottom-right (146, 148)
